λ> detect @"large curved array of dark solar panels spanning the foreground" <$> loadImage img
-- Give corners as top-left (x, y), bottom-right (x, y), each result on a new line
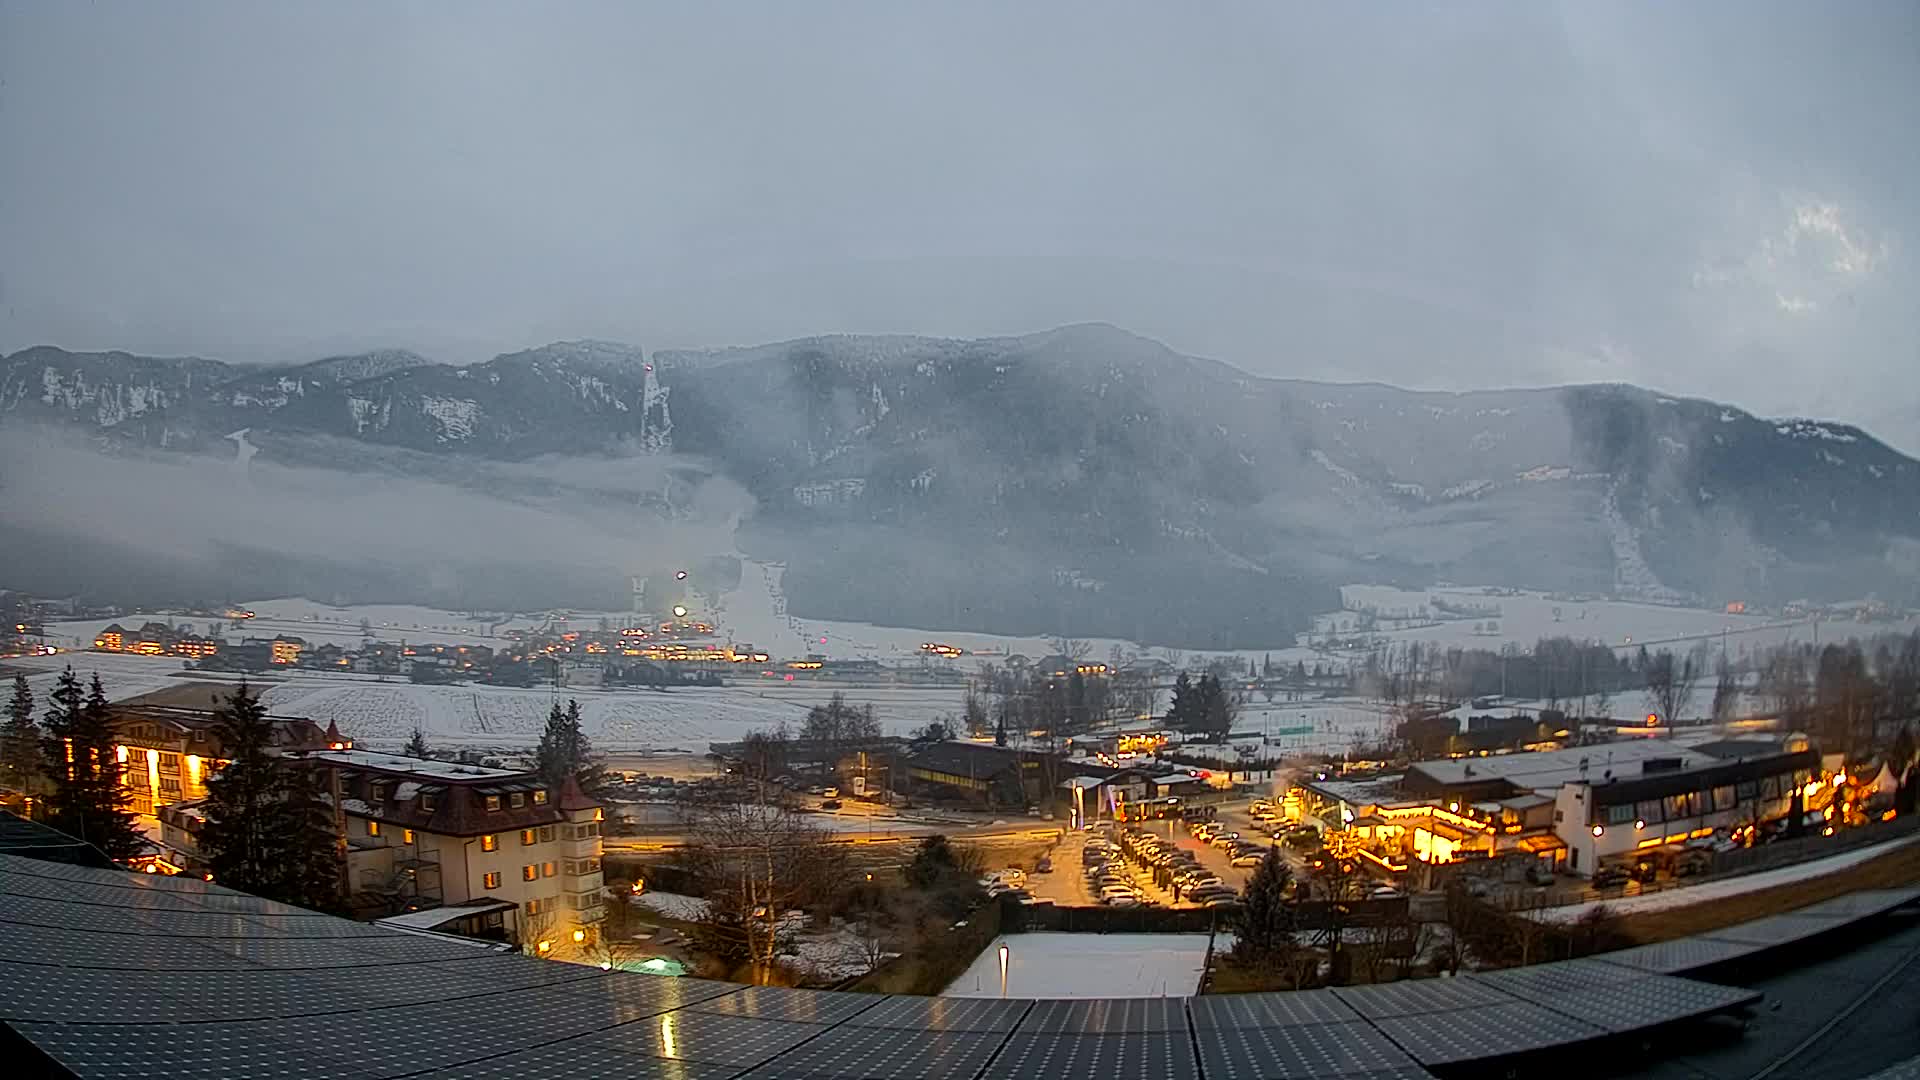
top-left (0, 855), bottom-right (1797, 1080)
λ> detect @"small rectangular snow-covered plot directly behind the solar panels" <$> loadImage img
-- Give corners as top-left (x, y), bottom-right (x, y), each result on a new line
top-left (941, 934), bottom-right (1206, 997)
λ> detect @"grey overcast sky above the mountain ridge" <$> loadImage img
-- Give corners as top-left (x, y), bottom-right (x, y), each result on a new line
top-left (0, 0), bottom-right (1920, 452)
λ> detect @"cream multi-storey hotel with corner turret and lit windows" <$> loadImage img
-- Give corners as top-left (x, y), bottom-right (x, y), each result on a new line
top-left (300, 749), bottom-right (607, 951)
